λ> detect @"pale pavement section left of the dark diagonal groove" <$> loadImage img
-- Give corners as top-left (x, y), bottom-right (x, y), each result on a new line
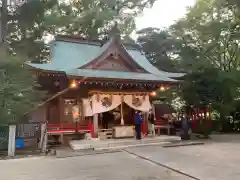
top-left (0, 152), bottom-right (190, 180)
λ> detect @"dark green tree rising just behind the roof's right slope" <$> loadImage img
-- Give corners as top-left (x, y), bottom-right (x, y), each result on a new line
top-left (137, 28), bottom-right (179, 72)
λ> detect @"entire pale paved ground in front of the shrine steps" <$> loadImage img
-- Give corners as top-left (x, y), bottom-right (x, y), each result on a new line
top-left (0, 135), bottom-right (240, 180)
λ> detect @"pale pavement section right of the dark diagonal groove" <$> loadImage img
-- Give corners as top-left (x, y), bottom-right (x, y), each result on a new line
top-left (126, 141), bottom-right (240, 180)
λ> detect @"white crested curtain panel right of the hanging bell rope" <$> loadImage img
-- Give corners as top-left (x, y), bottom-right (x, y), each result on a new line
top-left (123, 95), bottom-right (152, 112)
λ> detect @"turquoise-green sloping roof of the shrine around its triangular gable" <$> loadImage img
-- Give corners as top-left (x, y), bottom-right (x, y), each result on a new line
top-left (29, 38), bottom-right (184, 82)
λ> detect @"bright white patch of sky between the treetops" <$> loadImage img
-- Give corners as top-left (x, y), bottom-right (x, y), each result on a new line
top-left (136, 0), bottom-right (196, 30)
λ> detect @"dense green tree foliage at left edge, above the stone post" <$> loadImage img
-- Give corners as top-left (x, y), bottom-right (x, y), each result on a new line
top-left (0, 53), bottom-right (45, 124)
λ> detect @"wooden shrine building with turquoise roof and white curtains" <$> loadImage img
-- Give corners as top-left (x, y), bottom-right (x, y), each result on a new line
top-left (28, 33), bottom-right (183, 141)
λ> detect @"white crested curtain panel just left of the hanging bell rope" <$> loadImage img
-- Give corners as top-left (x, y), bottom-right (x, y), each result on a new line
top-left (92, 94), bottom-right (121, 114)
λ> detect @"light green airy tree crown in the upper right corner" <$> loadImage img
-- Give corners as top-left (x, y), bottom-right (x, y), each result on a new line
top-left (171, 0), bottom-right (240, 72)
